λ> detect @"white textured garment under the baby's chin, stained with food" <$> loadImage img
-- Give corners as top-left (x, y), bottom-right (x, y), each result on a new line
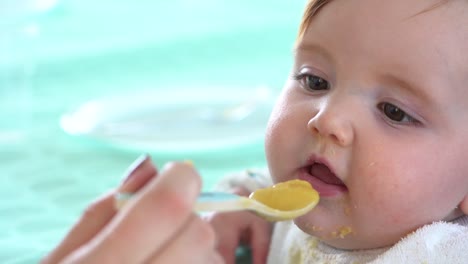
top-left (268, 216), bottom-right (468, 264)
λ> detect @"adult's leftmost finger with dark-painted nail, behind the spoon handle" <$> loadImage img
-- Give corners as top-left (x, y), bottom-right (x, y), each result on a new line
top-left (42, 155), bottom-right (156, 264)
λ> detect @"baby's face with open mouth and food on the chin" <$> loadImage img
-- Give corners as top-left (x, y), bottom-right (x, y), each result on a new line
top-left (266, 0), bottom-right (468, 249)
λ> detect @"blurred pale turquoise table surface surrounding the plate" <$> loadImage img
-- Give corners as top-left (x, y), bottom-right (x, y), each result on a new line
top-left (0, 0), bottom-right (304, 263)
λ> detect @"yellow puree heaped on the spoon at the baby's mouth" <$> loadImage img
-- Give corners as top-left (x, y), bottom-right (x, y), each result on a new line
top-left (250, 180), bottom-right (319, 211)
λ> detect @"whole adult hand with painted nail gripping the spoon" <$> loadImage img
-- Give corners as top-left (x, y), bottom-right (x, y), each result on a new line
top-left (42, 157), bottom-right (222, 264)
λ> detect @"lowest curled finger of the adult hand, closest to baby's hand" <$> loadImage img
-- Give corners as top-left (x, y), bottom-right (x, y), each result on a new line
top-left (147, 214), bottom-right (222, 264)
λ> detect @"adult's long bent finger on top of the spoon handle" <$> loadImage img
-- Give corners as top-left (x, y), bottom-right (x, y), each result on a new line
top-left (68, 163), bottom-right (201, 263)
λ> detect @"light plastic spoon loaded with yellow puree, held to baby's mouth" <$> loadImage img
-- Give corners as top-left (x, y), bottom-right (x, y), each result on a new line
top-left (116, 180), bottom-right (319, 222)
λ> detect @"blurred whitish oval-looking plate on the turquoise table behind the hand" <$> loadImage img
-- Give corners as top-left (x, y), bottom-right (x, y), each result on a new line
top-left (60, 87), bottom-right (273, 152)
